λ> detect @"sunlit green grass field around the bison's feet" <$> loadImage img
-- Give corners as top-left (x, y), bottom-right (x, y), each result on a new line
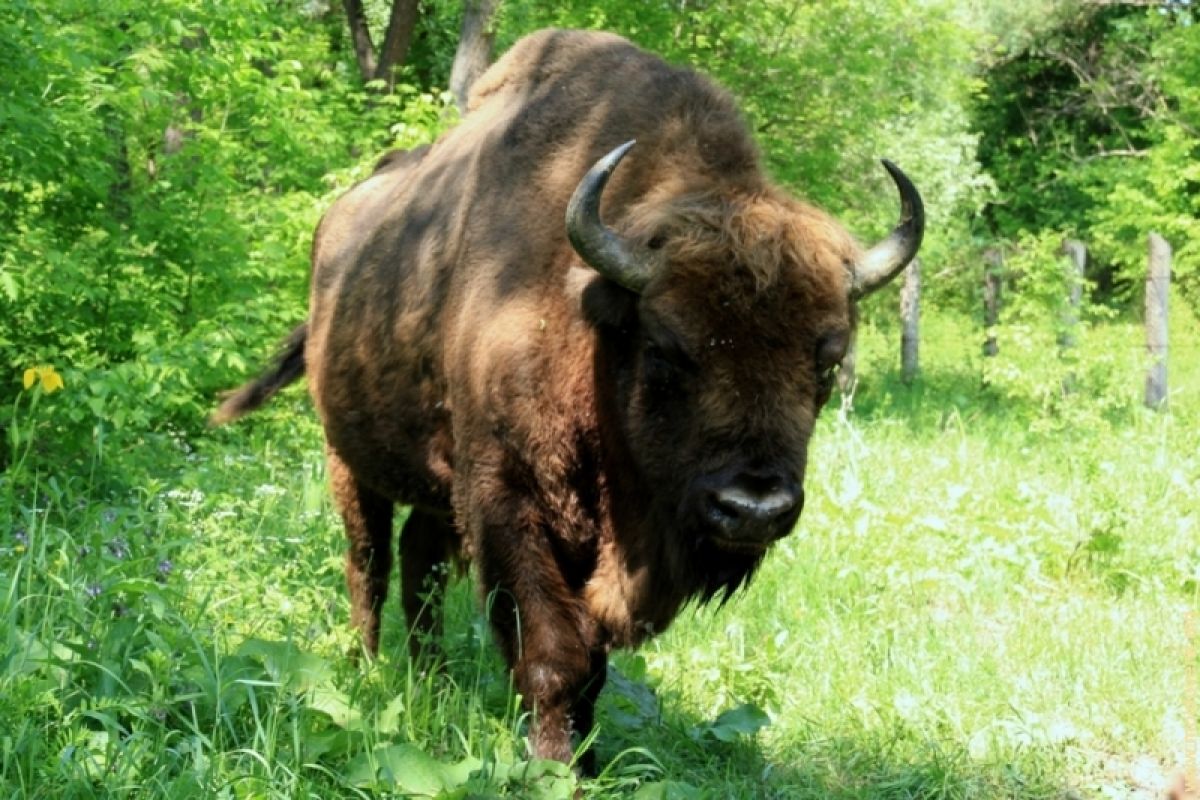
top-left (0, 307), bottom-right (1200, 799)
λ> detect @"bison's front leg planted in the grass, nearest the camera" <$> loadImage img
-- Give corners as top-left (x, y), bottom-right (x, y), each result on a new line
top-left (480, 528), bottom-right (606, 771)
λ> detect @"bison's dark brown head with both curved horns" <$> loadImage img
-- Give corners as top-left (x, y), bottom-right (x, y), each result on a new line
top-left (568, 143), bottom-right (924, 595)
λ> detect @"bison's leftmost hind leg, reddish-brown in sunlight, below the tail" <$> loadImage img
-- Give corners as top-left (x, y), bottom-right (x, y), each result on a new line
top-left (329, 451), bottom-right (392, 656)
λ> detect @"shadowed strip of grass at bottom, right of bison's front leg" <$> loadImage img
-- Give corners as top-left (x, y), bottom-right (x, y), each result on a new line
top-left (583, 671), bottom-right (1072, 799)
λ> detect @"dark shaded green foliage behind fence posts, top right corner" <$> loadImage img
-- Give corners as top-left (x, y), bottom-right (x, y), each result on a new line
top-left (974, 2), bottom-right (1200, 308)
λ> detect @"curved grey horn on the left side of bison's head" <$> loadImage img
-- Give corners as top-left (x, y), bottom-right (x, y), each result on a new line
top-left (566, 142), bottom-right (650, 293)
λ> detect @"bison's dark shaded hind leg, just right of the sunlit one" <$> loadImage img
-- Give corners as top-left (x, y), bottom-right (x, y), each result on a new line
top-left (400, 507), bottom-right (456, 661)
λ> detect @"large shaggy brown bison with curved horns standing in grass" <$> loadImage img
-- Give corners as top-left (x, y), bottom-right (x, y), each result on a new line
top-left (215, 30), bottom-right (924, 765)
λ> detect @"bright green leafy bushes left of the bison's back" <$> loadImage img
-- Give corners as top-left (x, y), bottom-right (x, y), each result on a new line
top-left (0, 0), bottom-right (452, 455)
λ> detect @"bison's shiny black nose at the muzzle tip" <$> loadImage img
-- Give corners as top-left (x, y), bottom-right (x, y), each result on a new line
top-left (708, 475), bottom-right (804, 540)
